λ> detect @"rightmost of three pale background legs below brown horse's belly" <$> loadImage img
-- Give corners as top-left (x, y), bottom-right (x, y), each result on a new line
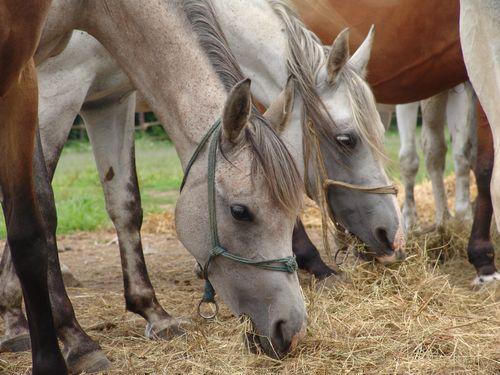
top-left (446, 83), bottom-right (474, 220)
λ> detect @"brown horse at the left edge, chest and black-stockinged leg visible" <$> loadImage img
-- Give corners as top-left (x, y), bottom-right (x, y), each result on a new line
top-left (0, 0), bottom-right (66, 374)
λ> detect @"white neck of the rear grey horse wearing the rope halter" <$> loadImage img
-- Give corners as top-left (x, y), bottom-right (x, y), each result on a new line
top-left (211, 0), bottom-right (304, 176)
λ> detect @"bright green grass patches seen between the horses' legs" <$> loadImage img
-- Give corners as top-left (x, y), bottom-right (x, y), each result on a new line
top-left (0, 128), bottom-right (453, 238)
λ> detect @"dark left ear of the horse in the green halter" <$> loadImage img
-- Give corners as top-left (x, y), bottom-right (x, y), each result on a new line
top-left (222, 78), bottom-right (252, 143)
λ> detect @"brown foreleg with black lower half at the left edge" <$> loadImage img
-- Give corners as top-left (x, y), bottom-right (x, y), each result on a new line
top-left (0, 61), bottom-right (67, 374)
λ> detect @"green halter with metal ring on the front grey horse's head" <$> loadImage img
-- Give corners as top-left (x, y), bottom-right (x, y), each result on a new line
top-left (180, 119), bottom-right (298, 319)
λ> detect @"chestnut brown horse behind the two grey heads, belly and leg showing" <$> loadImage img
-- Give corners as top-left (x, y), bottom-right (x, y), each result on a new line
top-left (293, 0), bottom-right (496, 282)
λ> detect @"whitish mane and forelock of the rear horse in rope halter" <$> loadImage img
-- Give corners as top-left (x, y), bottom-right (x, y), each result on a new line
top-left (268, 0), bottom-right (385, 159)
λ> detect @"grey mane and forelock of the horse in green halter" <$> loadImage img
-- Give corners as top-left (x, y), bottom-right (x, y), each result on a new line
top-left (181, 0), bottom-right (304, 216)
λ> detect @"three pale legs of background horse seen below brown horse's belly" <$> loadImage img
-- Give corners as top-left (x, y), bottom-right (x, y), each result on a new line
top-left (396, 83), bottom-right (475, 230)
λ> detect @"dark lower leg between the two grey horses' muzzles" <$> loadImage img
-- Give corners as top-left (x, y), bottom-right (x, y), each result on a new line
top-left (292, 220), bottom-right (335, 280)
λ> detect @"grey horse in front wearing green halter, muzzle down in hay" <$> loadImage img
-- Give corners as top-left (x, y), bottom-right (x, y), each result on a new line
top-left (1, 0), bottom-right (306, 372)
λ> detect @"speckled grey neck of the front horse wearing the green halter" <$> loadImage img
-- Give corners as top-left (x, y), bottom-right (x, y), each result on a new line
top-left (48, 0), bottom-right (227, 166)
